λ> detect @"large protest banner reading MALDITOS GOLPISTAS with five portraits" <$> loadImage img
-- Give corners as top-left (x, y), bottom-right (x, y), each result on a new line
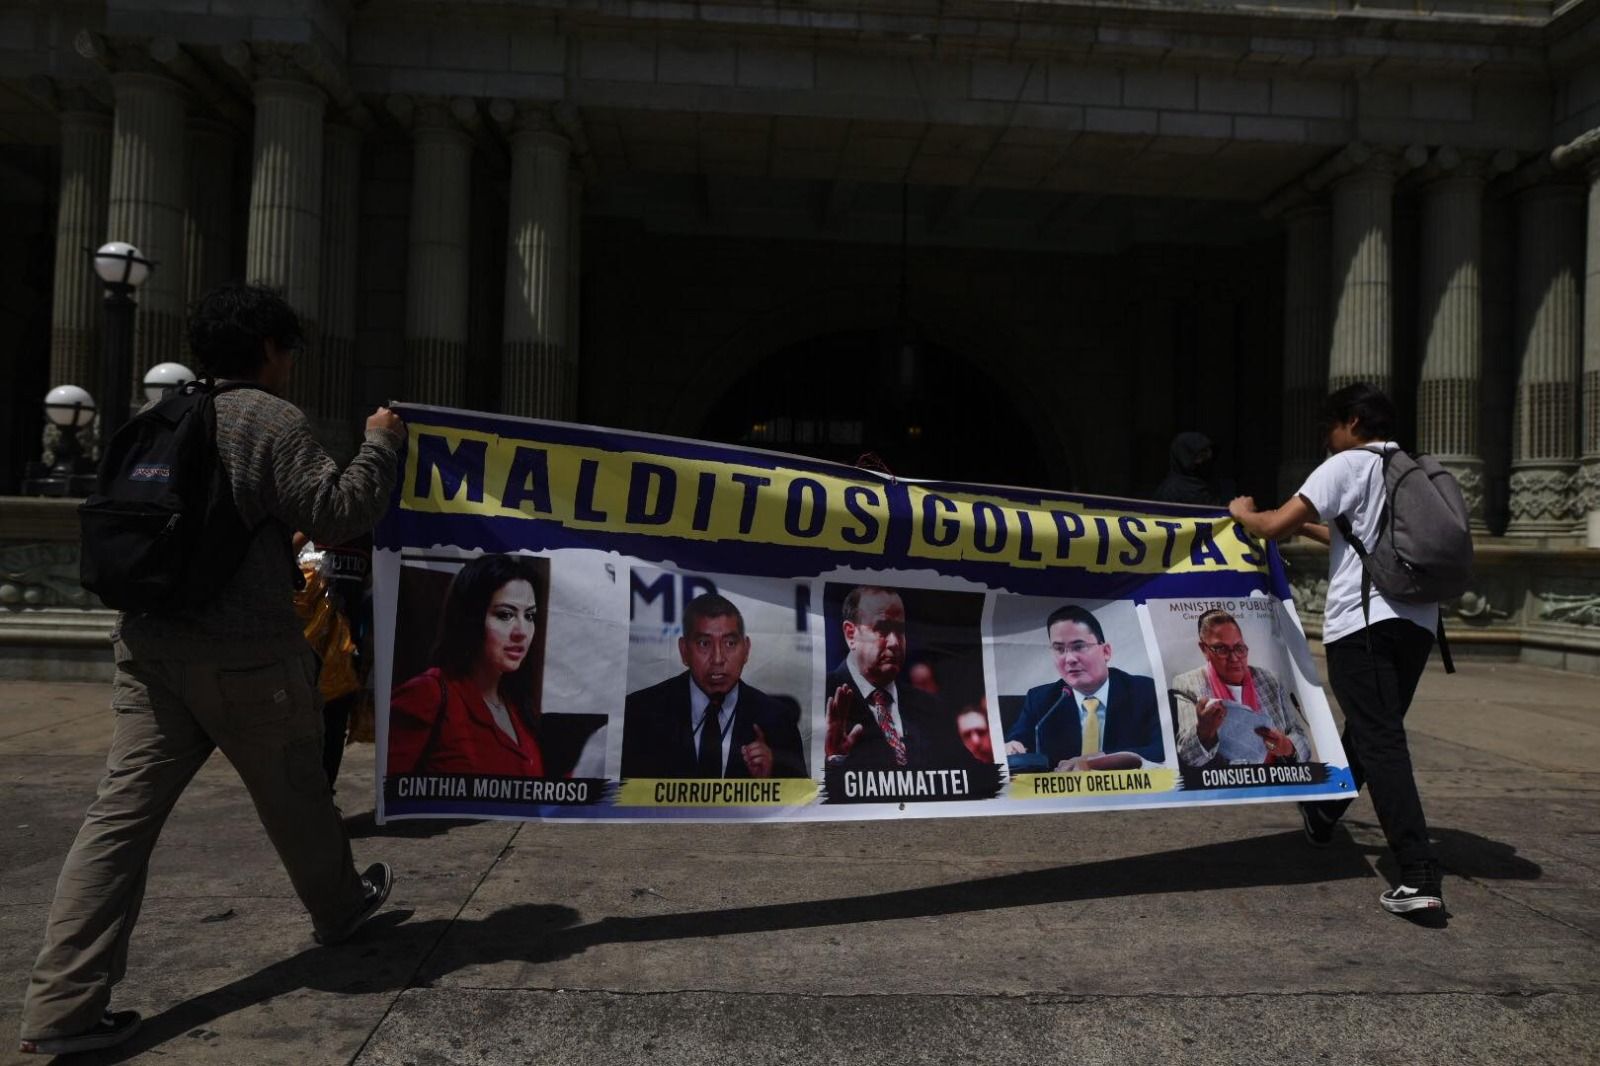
top-left (373, 405), bottom-right (1354, 821)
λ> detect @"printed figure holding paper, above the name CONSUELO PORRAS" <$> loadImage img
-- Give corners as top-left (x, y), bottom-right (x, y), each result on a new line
top-left (1171, 607), bottom-right (1314, 770)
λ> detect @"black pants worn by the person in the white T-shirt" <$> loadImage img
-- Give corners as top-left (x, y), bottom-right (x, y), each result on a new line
top-left (1317, 618), bottom-right (1434, 866)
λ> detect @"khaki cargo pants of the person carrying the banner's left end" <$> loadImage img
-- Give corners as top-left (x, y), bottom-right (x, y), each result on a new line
top-left (22, 643), bottom-right (363, 1039)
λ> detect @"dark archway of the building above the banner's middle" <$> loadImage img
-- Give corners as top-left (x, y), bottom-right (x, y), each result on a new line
top-left (699, 330), bottom-right (1070, 487)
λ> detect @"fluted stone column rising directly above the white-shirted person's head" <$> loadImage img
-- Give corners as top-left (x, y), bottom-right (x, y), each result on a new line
top-left (1328, 155), bottom-right (1395, 392)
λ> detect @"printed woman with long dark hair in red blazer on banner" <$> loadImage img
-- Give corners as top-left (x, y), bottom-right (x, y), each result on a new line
top-left (389, 555), bottom-right (544, 778)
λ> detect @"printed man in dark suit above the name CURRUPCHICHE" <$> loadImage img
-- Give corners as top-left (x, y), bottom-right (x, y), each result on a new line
top-left (622, 592), bottom-right (810, 778)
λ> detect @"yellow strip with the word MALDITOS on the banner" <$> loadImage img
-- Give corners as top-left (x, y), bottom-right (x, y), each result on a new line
top-left (400, 423), bottom-right (890, 555)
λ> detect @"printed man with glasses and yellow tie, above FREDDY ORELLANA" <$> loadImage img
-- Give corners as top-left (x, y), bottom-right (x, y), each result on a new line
top-left (1005, 603), bottom-right (1165, 771)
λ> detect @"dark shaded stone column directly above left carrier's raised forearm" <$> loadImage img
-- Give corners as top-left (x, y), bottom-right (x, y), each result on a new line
top-left (309, 123), bottom-right (361, 451)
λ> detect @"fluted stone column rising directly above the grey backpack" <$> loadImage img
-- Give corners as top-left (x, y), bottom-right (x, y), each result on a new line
top-left (1418, 166), bottom-right (1485, 521)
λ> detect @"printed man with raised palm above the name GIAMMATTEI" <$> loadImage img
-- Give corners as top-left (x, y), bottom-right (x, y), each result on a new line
top-left (822, 586), bottom-right (978, 770)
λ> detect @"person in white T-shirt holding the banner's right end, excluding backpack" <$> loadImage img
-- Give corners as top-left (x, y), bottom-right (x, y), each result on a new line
top-left (1229, 383), bottom-right (1445, 914)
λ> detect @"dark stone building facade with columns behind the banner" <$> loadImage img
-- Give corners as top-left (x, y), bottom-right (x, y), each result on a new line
top-left (0, 0), bottom-right (1600, 672)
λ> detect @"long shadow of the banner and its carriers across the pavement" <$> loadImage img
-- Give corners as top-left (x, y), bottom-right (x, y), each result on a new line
top-left (74, 829), bottom-right (1541, 1063)
